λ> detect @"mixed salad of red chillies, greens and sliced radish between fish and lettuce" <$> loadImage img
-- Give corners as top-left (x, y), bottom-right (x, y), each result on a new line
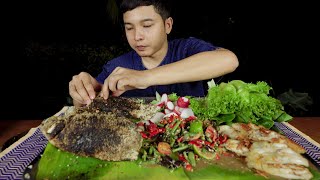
top-left (137, 94), bottom-right (227, 171)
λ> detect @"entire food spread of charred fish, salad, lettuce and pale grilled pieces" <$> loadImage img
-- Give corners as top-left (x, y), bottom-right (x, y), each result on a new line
top-left (41, 80), bottom-right (313, 179)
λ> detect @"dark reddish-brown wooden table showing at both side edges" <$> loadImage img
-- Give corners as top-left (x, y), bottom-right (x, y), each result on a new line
top-left (0, 117), bottom-right (320, 147)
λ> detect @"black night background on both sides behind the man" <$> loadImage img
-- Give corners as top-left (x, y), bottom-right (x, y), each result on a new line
top-left (0, 0), bottom-right (320, 119)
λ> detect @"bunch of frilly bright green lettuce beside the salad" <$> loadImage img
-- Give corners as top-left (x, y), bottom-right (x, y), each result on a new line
top-left (190, 80), bottom-right (292, 128)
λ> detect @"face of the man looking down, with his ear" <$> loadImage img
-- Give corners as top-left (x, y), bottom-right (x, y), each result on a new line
top-left (123, 6), bottom-right (172, 57)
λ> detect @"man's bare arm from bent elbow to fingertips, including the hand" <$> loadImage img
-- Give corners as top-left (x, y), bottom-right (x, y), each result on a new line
top-left (102, 49), bottom-right (239, 98)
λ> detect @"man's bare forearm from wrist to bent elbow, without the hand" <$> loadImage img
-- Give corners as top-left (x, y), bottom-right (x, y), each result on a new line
top-left (145, 49), bottom-right (239, 86)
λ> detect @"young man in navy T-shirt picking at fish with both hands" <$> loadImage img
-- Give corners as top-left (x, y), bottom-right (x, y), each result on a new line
top-left (69, 0), bottom-right (238, 106)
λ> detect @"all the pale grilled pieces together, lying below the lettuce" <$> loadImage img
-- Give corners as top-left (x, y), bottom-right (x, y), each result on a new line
top-left (219, 123), bottom-right (313, 179)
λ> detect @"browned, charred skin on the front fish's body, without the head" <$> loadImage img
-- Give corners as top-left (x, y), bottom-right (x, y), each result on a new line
top-left (51, 113), bottom-right (142, 161)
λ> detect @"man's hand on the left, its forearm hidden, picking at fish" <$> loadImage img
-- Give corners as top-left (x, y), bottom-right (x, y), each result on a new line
top-left (69, 72), bottom-right (102, 106)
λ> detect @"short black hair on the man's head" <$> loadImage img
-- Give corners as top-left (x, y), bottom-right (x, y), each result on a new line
top-left (120, 0), bottom-right (171, 20)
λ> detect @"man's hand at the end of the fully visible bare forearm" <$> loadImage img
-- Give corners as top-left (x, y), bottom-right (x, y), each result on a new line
top-left (101, 67), bottom-right (149, 99)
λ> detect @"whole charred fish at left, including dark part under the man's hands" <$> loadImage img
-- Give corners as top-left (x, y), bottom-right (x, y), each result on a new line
top-left (40, 97), bottom-right (155, 161)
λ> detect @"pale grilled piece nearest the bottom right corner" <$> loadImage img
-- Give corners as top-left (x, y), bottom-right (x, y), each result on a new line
top-left (246, 141), bottom-right (313, 179)
